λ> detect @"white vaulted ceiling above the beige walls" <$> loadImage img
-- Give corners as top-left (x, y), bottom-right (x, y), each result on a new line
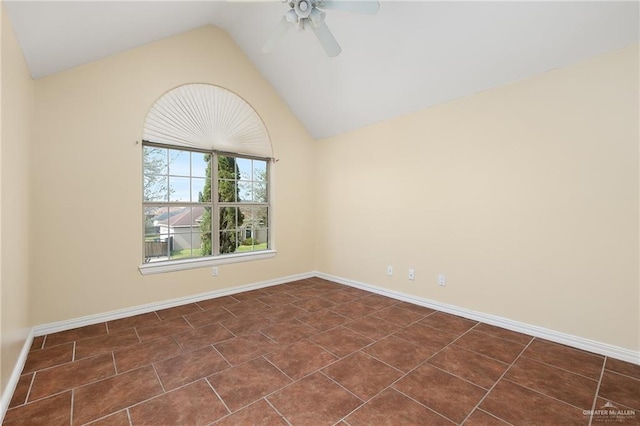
top-left (4, 0), bottom-right (640, 139)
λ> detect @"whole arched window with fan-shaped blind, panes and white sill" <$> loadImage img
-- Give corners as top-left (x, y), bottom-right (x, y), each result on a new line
top-left (140, 84), bottom-right (275, 273)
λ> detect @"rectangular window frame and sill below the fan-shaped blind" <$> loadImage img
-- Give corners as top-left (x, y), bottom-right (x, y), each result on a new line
top-left (138, 141), bottom-right (277, 275)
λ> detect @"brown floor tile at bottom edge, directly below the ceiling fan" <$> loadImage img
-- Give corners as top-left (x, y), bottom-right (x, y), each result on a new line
top-left (267, 373), bottom-right (362, 426)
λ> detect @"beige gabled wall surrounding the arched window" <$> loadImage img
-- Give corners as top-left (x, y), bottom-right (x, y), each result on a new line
top-left (31, 27), bottom-right (315, 325)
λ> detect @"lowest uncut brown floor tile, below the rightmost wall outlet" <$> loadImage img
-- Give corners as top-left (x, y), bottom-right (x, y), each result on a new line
top-left (393, 364), bottom-right (486, 423)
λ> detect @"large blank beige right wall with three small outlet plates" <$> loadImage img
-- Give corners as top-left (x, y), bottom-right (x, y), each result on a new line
top-left (316, 45), bottom-right (640, 351)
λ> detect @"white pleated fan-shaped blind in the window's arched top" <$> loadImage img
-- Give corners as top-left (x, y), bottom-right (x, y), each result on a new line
top-left (143, 83), bottom-right (273, 158)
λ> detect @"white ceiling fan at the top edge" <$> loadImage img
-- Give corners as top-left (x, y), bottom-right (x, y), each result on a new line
top-left (262, 0), bottom-right (380, 57)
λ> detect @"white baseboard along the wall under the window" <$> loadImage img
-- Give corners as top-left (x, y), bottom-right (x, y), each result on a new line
top-left (33, 272), bottom-right (316, 336)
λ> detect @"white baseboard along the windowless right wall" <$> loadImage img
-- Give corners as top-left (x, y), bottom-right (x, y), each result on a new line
top-left (312, 272), bottom-right (640, 364)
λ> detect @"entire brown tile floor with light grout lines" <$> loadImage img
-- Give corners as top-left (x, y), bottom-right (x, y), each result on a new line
top-left (4, 278), bottom-right (640, 426)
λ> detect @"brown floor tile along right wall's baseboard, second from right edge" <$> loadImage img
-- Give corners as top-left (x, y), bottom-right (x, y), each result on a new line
top-left (523, 338), bottom-right (604, 380)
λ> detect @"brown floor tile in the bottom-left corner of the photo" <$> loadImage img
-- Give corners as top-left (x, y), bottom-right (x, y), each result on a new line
top-left (2, 392), bottom-right (71, 426)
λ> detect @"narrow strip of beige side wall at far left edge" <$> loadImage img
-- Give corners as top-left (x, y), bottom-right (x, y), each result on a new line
top-left (0, 6), bottom-right (33, 400)
